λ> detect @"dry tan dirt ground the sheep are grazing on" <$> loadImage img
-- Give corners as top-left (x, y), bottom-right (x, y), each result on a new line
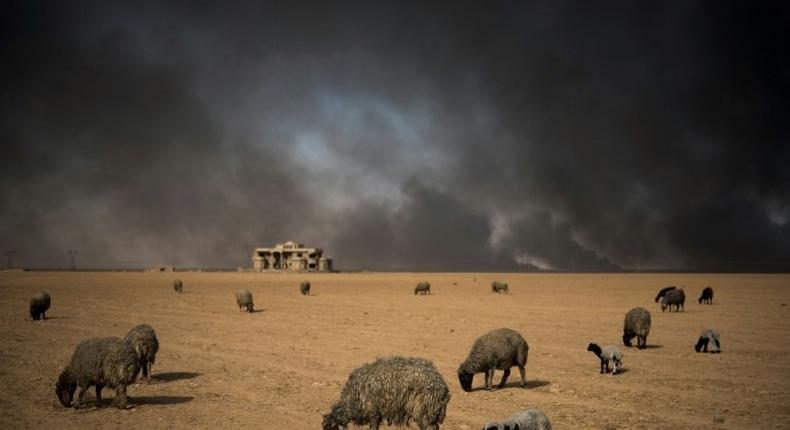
top-left (0, 272), bottom-right (790, 429)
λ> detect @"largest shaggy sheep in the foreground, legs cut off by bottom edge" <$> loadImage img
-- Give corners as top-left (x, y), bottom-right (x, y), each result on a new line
top-left (322, 357), bottom-right (450, 430)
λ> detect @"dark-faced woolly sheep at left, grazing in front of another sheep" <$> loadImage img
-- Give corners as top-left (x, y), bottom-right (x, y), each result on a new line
top-left (55, 337), bottom-right (140, 409)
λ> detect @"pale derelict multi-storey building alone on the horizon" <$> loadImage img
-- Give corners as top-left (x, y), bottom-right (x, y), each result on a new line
top-left (252, 241), bottom-right (332, 272)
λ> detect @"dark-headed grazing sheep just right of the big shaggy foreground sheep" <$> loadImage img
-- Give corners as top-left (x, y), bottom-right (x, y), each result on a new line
top-left (458, 328), bottom-right (529, 392)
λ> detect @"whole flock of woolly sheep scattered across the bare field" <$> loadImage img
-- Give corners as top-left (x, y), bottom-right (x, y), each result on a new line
top-left (30, 280), bottom-right (721, 430)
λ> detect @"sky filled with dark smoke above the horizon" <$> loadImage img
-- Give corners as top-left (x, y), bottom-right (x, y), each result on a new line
top-left (0, 0), bottom-right (790, 271)
